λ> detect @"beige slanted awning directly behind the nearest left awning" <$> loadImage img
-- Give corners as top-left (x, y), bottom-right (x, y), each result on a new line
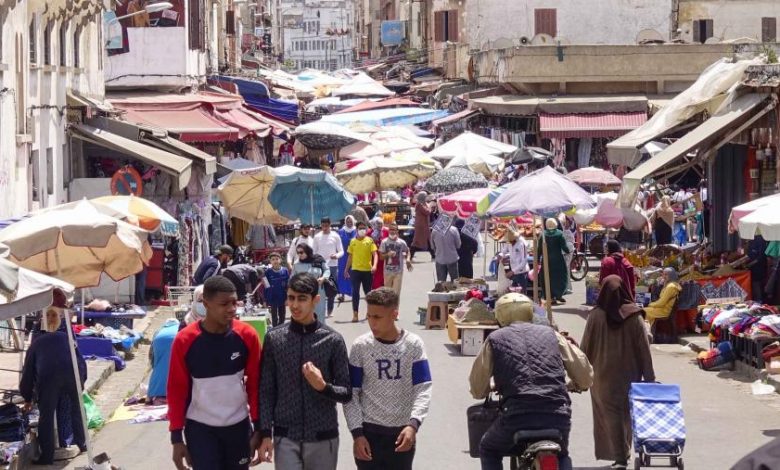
top-left (86, 117), bottom-right (217, 175)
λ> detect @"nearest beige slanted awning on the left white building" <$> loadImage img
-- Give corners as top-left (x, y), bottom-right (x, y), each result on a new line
top-left (70, 124), bottom-right (192, 189)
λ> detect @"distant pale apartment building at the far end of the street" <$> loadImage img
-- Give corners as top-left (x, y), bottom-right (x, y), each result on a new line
top-left (275, 0), bottom-right (355, 70)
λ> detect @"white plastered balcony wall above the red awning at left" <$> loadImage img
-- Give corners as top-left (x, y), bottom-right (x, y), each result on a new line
top-left (104, 27), bottom-right (206, 90)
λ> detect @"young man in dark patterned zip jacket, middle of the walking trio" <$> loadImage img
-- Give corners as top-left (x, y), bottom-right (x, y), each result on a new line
top-left (258, 273), bottom-right (352, 470)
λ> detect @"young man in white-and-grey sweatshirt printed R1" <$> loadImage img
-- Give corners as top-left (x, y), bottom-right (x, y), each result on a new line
top-left (344, 287), bottom-right (433, 470)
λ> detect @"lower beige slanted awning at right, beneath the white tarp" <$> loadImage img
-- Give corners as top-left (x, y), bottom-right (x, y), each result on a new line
top-left (618, 93), bottom-right (776, 207)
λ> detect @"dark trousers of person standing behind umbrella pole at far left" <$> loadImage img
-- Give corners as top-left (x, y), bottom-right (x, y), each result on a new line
top-left (38, 378), bottom-right (87, 464)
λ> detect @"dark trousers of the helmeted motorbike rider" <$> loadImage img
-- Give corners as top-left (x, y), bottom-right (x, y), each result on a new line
top-left (479, 411), bottom-right (572, 470)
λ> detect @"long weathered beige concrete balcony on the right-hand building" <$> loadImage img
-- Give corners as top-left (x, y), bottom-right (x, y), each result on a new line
top-left (470, 44), bottom-right (739, 95)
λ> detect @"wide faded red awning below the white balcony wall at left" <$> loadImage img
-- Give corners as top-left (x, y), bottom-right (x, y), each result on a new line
top-left (120, 107), bottom-right (240, 142)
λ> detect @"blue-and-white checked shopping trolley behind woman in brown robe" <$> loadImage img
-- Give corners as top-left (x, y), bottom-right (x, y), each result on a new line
top-left (629, 383), bottom-right (685, 470)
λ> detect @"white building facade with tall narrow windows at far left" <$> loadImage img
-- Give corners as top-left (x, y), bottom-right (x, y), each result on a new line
top-left (0, 0), bottom-right (104, 217)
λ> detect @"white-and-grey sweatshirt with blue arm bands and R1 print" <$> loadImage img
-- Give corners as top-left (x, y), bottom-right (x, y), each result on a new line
top-left (344, 331), bottom-right (433, 437)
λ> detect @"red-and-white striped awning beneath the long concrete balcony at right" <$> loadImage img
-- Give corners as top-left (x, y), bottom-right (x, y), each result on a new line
top-left (539, 112), bottom-right (647, 139)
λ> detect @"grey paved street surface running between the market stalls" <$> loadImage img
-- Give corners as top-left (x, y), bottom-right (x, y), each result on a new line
top-left (68, 254), bottom-right (780, 470)
